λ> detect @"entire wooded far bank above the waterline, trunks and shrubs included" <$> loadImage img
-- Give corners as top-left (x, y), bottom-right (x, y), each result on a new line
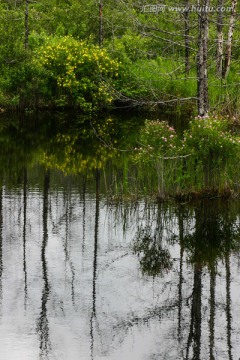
top-left (0, 0), bottom-right (240, 116)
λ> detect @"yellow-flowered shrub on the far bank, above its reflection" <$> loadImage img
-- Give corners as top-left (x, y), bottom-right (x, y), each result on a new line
top-left (35, 36), bottom-right (118, 110)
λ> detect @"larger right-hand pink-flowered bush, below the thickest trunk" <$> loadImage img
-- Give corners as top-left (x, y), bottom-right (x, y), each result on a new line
top-left (182, 117), bottom-right (240, 188)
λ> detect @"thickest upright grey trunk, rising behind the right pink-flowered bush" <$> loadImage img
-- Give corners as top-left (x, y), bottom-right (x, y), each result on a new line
top-left (197, 0), bottom-right (210, 116)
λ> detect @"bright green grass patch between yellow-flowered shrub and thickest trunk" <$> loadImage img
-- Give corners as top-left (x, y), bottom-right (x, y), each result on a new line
top-left (114, 56), bottom-right (197, 105)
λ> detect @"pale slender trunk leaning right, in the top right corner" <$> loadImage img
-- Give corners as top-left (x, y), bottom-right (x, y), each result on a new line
top-left (223, 0), bottom-right (237, 79)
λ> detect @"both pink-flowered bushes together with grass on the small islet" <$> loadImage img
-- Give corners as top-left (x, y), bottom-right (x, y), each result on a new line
top-left (133, 117), bottom-right (240, 198)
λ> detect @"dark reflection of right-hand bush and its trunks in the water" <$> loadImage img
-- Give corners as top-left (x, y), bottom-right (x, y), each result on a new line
top-left (183, 202), bottom-right (240, 360)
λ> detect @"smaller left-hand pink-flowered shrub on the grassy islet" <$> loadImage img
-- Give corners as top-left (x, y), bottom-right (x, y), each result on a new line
top-left (133, 120), bottom-right (180, 198)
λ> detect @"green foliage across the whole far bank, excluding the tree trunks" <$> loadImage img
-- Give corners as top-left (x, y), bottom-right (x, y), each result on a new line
top-left (0, 0), bottom-right (240, 115)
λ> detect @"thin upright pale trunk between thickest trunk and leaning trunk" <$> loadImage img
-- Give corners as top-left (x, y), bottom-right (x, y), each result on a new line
top-left (217, 0), bottom-right (224, 78)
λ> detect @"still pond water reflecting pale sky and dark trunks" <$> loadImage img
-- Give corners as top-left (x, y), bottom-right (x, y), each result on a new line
top-left (0, 113), bottom-right (240, 360)
